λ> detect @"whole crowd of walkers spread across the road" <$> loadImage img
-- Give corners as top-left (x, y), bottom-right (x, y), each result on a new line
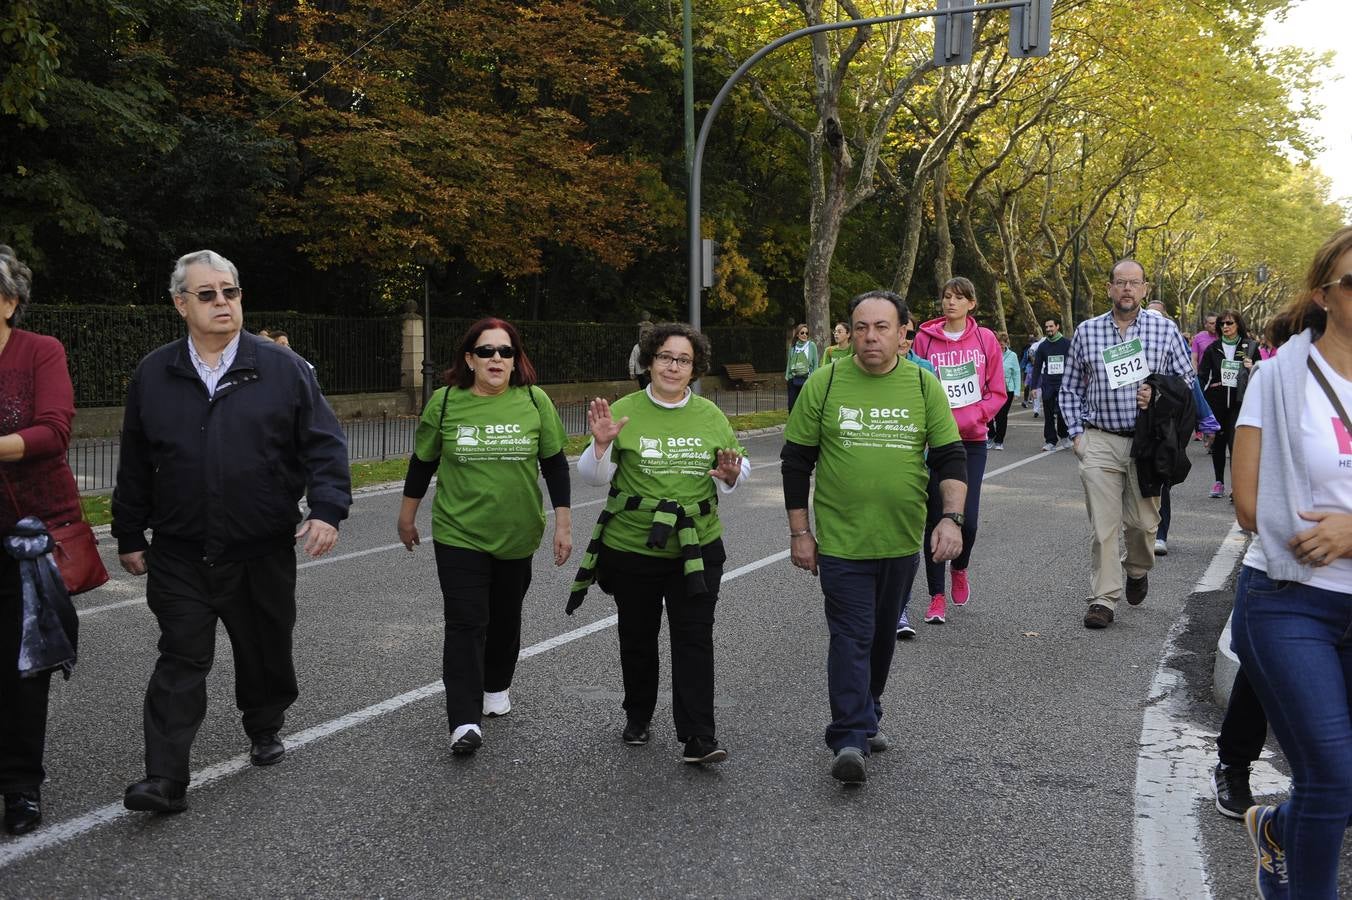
top-left (0, 228), bottom-right (1352, 897)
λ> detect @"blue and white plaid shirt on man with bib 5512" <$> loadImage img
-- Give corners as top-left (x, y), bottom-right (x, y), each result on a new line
top-left (1057, 309), bottom-right (1195, 438)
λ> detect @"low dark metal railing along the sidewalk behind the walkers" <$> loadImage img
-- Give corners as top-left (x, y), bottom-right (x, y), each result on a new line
top-left (66, 388), bottom-right (788, 493)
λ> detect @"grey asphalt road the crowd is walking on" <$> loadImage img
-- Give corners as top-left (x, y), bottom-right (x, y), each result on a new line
top-left (0, 409), bottom-right (1348, 899)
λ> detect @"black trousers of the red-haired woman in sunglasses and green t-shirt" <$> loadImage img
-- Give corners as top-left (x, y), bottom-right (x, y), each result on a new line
top-left (434, 543), bottom-right (531, 731)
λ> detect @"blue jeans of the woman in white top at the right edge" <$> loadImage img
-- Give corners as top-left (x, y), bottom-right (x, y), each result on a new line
top-left (1232, 566), bottom-right (1352, 900)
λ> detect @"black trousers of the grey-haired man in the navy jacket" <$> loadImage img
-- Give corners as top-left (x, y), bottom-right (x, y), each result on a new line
top-left (145, 546), bottom-right (299, 784)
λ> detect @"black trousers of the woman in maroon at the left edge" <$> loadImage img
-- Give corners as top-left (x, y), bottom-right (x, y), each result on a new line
top-left (0, 551), bottom-right (80, 793)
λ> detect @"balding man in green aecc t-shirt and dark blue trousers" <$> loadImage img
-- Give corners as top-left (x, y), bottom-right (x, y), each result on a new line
top-left (780, 291), bottom-right (967, 784)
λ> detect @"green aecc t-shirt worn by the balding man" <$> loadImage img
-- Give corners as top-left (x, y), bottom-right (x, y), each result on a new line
top-left (784, 359), bottom-right (960, 559)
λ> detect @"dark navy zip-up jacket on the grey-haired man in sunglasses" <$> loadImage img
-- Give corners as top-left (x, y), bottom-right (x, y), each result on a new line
top-left (112, 332), bottom-right (352, 562)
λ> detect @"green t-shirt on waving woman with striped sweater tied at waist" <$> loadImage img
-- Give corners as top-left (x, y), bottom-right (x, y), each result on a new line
top-left (594, 391), bottom-right (746, 558)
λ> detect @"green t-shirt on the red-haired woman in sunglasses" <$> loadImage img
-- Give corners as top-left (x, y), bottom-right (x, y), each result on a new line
top-left (414, 386), bottom-right (564, 559)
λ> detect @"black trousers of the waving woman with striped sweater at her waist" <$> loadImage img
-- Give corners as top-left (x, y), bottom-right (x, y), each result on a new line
top-left (596, 539), bottom-right (727, 741)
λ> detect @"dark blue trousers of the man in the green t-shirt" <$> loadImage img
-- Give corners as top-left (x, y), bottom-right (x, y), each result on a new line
top-left (817, 553), bottom-right (921, 755)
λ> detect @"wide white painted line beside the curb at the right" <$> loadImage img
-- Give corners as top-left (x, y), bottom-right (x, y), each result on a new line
top-left (1132, 516), bottom-right (1245, 900)
